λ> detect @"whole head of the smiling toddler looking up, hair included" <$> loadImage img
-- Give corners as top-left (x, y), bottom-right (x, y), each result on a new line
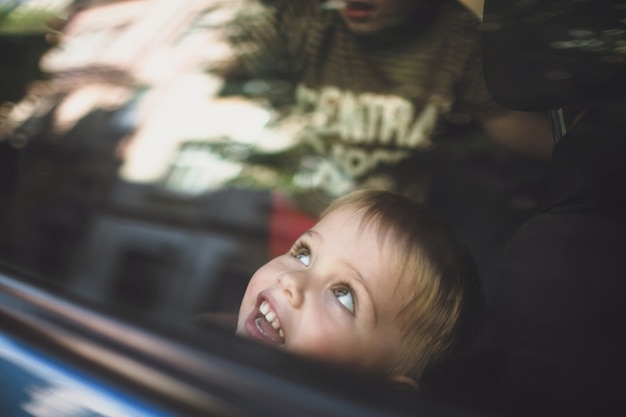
top-left (237, 191), bottom-right (480, 381)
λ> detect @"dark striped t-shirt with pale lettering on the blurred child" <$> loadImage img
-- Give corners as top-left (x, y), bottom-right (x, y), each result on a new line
top-left (227, 0), bottom-right (504, 212)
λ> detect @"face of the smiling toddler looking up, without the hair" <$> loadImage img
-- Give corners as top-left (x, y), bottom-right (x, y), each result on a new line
top-left (237, 209), bottom-right (412, 372)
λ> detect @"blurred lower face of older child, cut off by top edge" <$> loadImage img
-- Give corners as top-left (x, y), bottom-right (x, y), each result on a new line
top-left (339, 0), bottom-right (424, 35)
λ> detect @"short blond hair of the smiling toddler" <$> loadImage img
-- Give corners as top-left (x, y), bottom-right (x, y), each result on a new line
top-left (322, 190), bottom-right (482, 381)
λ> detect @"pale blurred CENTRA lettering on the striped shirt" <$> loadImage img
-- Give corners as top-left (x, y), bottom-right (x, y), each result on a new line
top-left (296, 85), bottom-right (447, 194)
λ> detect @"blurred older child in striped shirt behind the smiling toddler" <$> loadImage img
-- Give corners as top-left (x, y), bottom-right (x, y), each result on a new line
top-left (223, 0), bottom-right (553, 216)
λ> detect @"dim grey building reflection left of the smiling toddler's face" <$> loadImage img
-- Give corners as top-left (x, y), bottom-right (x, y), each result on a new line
top-left (72, 183), bottom-right (270, 319)
